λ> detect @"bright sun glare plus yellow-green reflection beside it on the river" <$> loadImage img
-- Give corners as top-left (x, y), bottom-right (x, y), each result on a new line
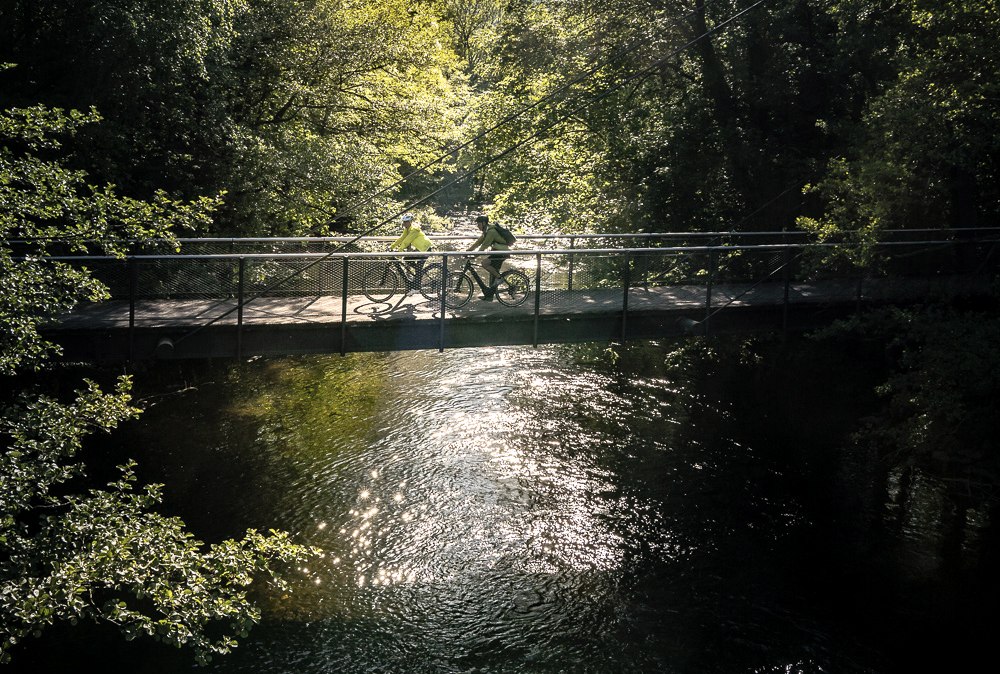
top-left (227, 349), bottom-right (644, 618)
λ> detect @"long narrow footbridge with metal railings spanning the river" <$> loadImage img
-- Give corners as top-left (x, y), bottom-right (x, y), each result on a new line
top-left (44, 229), bottom-right (1000, 361)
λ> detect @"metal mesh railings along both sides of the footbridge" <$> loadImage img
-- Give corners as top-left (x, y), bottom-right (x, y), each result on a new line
top-left (50, 232), bottom-right (998, 354)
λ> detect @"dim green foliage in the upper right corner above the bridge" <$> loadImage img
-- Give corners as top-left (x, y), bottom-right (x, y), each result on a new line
top-left (801, 0), bottom-right (1000, 230)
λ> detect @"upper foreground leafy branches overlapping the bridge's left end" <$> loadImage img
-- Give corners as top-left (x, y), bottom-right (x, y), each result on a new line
top-left (0, 106), bottom-right (214, 375)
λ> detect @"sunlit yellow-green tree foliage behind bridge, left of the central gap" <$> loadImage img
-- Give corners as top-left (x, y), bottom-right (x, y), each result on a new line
top-left (222, 0), bottom-right (463, 233)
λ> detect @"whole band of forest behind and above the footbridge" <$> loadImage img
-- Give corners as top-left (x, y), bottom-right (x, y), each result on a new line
top-left (0, 0), bottom-right (1000, 235)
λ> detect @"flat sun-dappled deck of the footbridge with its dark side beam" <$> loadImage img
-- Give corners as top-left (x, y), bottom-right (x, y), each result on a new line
top-left (48, 276), bottom-right (990, 360)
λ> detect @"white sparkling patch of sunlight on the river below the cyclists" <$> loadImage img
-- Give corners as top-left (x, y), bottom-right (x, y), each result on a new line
top-left (302, 349), bottom-right (640, 588)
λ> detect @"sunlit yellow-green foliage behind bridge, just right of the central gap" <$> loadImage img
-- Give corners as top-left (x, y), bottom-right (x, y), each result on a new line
top-left (463, 3), bottom-right (644, 231)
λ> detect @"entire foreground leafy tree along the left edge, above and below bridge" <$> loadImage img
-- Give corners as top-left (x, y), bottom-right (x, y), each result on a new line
top-left (0, 106), bottom-right (315, 661)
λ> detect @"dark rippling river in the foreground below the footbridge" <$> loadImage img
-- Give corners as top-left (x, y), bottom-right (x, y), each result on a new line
top-left (5, 340), bottom-right (995, 674)
